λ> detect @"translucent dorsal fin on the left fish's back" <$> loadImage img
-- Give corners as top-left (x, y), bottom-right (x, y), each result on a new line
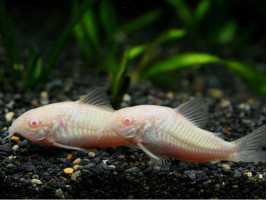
top-left (78, 89), bottom-right (114, 111)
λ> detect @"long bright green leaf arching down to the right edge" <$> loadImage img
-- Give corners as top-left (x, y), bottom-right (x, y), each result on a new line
top-left (142, 53), bottom-right (266, 94)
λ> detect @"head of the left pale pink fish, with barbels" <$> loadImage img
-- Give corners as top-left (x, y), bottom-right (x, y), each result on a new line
top-left (8, 105), bottom-right (61, 146)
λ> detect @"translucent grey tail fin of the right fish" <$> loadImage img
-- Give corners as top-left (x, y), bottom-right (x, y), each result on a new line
top-left (233, 125), bottom-right (266, 162)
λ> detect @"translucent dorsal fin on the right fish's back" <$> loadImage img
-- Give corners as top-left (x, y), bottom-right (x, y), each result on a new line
top-left (175, 98), bottom-right (209, 128)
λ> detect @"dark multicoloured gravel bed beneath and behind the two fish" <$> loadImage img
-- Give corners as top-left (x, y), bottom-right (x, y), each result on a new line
top-left (0, 68), bottom-right (266, 199)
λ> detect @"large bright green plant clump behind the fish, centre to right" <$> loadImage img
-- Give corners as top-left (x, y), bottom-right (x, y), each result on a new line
top-left (74, 0), bottom-right (265, 107)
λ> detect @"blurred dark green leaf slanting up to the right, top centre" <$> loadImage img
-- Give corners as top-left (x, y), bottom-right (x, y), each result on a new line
top-left (121, 9), bottom-right (162, 33)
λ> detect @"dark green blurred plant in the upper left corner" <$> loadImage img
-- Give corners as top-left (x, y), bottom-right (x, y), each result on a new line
top-left (0, 0), bottom-right (92, 89)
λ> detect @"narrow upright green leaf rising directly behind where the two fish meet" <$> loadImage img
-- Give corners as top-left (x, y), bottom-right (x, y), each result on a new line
top-left (111, 47), bottom-right (130, 109)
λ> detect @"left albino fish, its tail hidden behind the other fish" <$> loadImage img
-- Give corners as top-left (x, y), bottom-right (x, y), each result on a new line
top-left (4, 90), bottom-right (127, 150)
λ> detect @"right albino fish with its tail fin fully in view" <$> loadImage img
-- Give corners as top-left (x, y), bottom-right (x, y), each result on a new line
top-left (109, 99), bottom-right (266, 162)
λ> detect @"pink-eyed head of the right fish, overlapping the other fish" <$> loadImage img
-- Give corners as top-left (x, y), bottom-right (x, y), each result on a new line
top-left (110, 108), bottom-right (141, 142)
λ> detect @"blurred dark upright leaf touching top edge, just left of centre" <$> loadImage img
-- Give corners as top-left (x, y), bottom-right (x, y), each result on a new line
top-left (99, 0), bottom-right (117, 41)
